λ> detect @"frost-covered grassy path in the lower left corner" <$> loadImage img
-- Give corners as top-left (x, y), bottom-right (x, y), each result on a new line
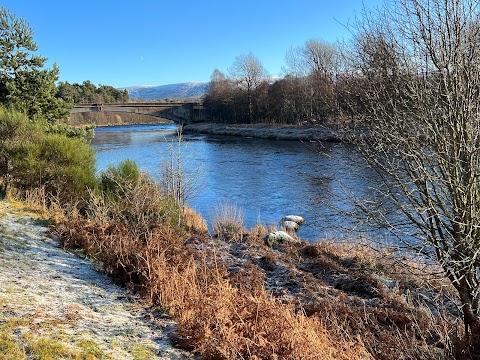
top-left (0, 201), bottom-right (188, 360)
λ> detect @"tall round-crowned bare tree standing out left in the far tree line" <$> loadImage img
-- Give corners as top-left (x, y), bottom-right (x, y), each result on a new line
top-left (229, 53), bottom-right (267, 121)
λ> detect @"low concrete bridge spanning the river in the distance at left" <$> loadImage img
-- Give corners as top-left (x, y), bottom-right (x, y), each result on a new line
top-left (70, 102), bottom-right (205, 124)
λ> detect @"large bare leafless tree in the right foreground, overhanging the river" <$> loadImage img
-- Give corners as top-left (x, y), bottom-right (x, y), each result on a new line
top-left (346, 0), bottom-right (480, 342)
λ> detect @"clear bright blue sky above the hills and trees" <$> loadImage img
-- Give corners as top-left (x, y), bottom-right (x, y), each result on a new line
top-left (1, 0), bottom-right (383, 87)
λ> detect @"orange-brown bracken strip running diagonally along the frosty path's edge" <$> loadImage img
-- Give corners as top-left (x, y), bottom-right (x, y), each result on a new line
top-left (57, 215), bottom-right (370, 359)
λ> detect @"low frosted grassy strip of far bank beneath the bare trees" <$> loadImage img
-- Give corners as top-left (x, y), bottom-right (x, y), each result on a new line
top-left (183, 123), bottom-right (344, 142)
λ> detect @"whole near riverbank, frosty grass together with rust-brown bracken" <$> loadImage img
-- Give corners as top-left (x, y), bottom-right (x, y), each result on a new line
top-left (0, 191), bottom-right (461, 360)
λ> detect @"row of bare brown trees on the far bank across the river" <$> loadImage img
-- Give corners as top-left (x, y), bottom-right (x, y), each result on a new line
top-left (204, 29), bottom-right (408, 125)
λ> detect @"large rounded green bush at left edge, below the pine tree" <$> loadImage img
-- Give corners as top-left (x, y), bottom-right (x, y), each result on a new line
top-left (0, 105), bottom-right (97, 204)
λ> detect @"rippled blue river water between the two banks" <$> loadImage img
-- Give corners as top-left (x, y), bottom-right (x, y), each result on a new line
top-left (92, 124), bottom-right (386, 240)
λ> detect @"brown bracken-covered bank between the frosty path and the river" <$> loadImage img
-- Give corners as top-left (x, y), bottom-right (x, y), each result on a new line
top-left (45, 171), bottom-right (469, 359)
